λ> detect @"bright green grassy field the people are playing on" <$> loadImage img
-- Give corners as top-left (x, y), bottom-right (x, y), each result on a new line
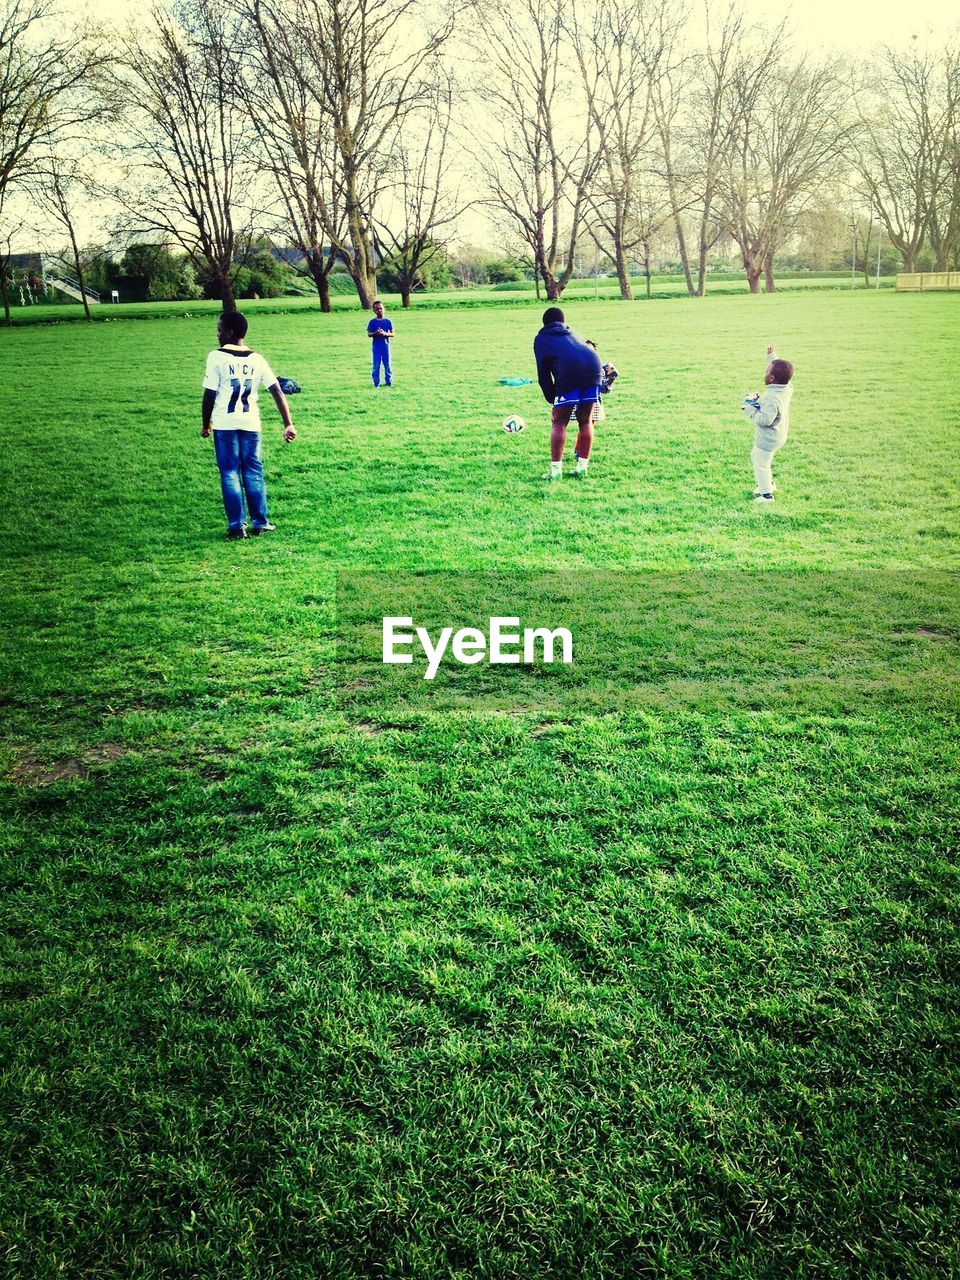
top-left (0, 289), bottom-right (960, 1280)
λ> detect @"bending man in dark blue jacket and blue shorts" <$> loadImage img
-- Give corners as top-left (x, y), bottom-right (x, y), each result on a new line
top-left (534, 307), bottom-right (603, 480)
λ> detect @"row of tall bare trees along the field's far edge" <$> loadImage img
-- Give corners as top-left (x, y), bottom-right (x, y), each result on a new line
top-left (0, 0), bottom-right (960, 325)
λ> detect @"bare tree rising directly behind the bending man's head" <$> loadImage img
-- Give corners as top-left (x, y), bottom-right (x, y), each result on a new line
top-left (471, 0), bottom-right (599, 301)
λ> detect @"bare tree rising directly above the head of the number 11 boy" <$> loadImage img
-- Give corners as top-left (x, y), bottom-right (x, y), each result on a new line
top-left (118, 0), bottom-right (255, 310)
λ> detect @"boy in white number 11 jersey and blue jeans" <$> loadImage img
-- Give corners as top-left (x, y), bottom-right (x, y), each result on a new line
top-left (200, 311), bottom-right (297, 538)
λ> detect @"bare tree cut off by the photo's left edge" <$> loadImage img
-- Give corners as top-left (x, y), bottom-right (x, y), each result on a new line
top-left (0, 0), bottom-right (108, 325)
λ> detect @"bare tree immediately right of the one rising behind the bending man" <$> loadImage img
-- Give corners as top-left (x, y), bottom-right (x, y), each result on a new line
top-left (571, 0), bottom-right (682, 300)
